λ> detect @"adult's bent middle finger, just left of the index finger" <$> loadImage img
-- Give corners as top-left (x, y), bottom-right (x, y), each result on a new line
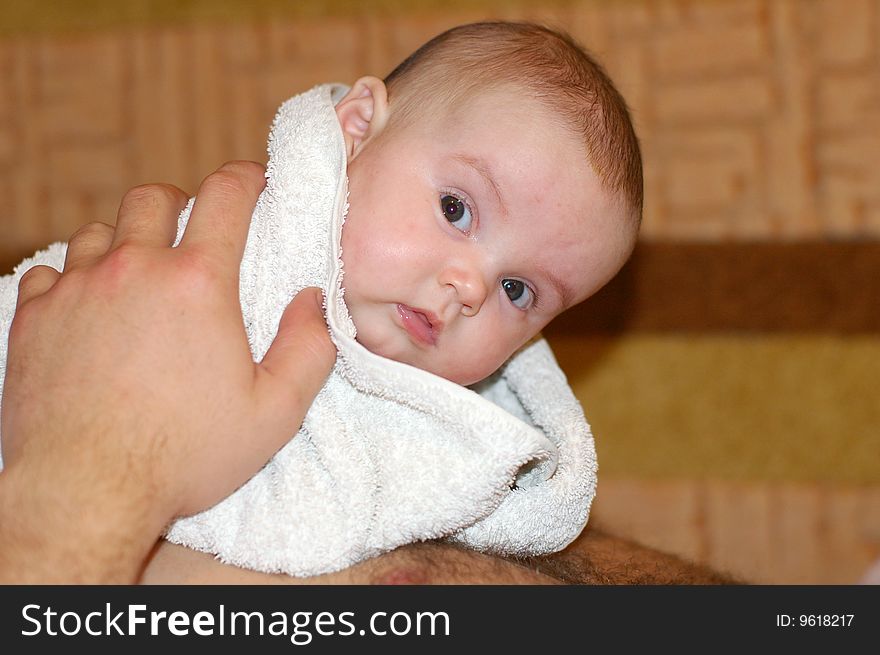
top-left (110, 184), bottom-right (189, 249)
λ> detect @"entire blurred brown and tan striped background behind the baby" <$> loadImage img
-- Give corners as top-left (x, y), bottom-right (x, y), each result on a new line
top-left (0, 0), bottom-right (880, 584)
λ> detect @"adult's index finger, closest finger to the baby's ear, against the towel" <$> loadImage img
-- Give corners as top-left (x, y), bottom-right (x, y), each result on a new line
top-left (180, 161), bottom-right (266, 280)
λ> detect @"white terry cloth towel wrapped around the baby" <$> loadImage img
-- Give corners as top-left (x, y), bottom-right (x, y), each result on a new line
top-left (0, 85), bottom-right (596, 576)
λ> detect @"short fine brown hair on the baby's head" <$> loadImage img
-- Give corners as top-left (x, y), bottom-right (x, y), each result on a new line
top-left (385, 22), bottom-right (643, 226)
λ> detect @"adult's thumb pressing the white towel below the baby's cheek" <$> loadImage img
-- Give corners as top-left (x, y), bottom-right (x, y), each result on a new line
top-left (256, 288), bottom-right (336, 439)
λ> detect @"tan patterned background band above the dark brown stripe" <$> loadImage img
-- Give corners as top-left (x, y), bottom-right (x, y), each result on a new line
top-left (0, 0), bottom-right (880, 260)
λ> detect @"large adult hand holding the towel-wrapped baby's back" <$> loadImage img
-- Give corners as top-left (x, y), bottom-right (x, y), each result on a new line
top-left (0, 162), bottom-right (335, 582)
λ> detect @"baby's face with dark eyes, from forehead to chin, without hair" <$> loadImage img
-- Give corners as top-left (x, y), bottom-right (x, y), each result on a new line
top-left (342, 90), bottom-right (632, 385)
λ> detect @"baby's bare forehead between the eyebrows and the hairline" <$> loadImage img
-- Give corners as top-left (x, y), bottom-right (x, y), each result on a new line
top-left (384, 84), bottom-right (630, 294)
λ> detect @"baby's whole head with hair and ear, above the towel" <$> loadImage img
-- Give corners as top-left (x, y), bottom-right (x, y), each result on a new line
top-left (336, 23), bottom-right (642, 385)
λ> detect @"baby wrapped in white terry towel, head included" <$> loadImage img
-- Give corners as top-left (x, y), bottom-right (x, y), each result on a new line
top-left (0, 23), bottom-right (642, 576)
